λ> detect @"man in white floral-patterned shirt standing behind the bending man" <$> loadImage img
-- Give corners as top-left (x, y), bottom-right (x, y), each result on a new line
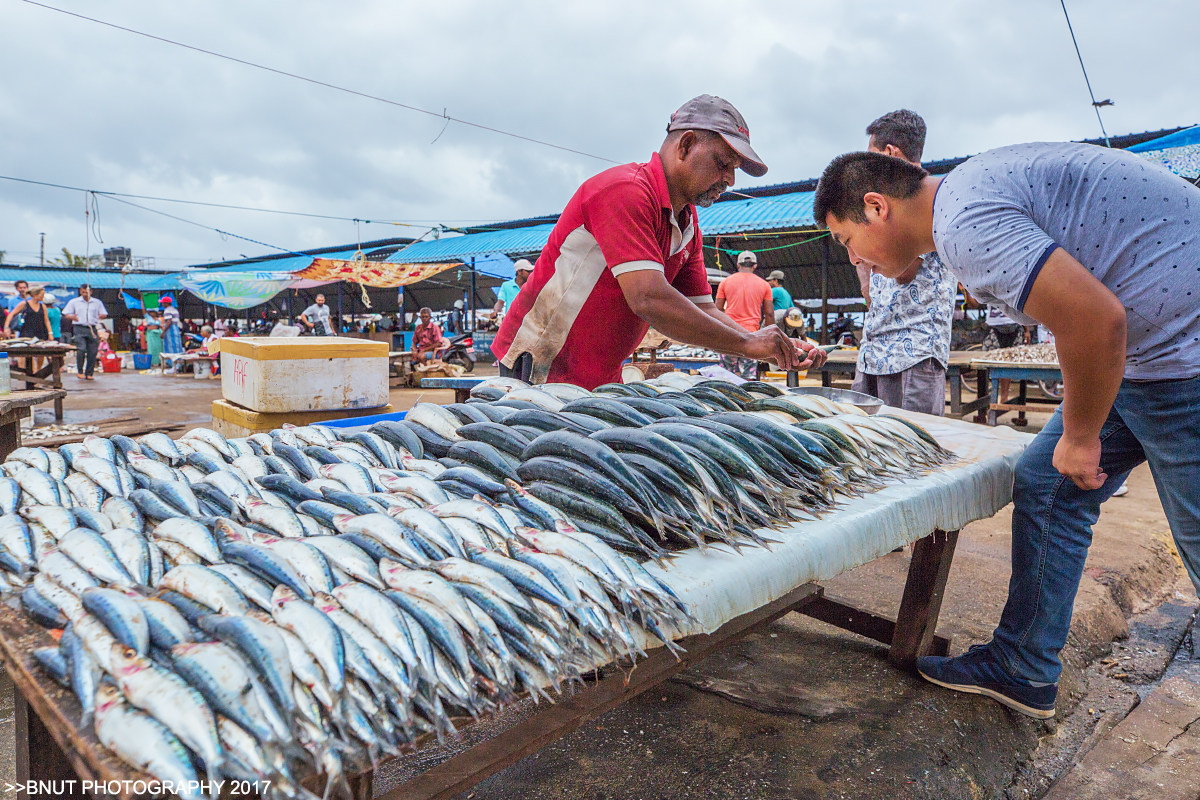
top-left (854, 109), bottom-right (958, 416)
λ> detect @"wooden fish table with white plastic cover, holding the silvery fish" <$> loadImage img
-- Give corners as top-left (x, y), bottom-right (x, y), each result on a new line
top-left (0, 410), bottom-right (1032, 800)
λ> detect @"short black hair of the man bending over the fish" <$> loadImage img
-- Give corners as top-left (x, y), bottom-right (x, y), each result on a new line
top-left (812, 152), bottom-right (929, 225)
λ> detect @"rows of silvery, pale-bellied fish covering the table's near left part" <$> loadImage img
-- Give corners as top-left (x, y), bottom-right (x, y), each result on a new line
top-left (0, 425), bottom-right (694, 798)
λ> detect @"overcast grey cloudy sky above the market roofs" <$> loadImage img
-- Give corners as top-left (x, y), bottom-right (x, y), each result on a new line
top-left (0, 0), bottom-right (1200, 267)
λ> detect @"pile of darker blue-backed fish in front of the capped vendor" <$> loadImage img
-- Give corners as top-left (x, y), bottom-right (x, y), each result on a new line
top-left (393, 373), bottom-right (953, 559)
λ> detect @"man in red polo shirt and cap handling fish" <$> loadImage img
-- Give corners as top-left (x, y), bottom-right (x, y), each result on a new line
top-left (492, 95), bottom-right (824, 389)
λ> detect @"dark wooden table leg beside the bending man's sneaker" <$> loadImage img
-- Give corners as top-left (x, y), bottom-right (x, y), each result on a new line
top-left (888, 530), bottom-right (959, 669)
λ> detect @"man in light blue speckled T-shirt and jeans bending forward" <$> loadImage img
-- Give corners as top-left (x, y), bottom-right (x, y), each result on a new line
top-left (814, 143), bottom-right (1200, 718)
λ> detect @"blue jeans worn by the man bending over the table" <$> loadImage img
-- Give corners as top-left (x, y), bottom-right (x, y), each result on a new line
top-left (990, 377), bottom-right (1200, 684)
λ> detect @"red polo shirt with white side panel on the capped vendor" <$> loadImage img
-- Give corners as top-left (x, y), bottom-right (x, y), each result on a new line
top-left (492, 154), bottom-right (713, 390)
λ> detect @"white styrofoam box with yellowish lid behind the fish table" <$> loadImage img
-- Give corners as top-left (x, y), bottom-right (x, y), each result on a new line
top-left (221, 336), bottom-right (388, 414)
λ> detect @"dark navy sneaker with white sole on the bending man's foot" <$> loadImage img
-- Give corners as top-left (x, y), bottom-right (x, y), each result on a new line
top-left (917, 644), bottom-right (1058, 720)
